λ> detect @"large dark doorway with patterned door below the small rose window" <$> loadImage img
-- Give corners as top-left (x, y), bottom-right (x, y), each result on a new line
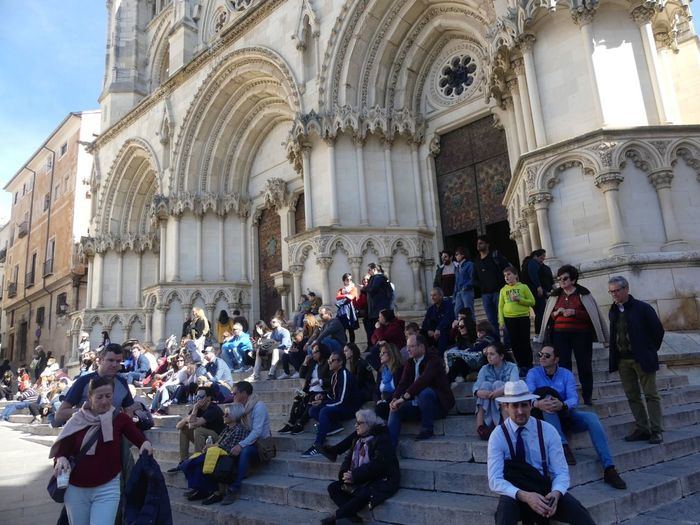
top-left (435, 117), bottom-right (518, 274)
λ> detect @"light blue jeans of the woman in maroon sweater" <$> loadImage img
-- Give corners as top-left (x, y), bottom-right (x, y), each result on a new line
top-left (64, 475), bottom-right (120, 525)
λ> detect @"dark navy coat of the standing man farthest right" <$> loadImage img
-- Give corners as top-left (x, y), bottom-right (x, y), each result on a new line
top-left (608, 295), bottom-right (664, 374)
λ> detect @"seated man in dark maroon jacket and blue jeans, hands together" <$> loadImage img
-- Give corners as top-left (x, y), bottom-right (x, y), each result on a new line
top-left (388, 335), bottom-right (455, 446)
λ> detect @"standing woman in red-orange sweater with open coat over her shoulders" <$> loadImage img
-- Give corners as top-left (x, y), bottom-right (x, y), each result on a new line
top-left (537, 264), bottom-right (610, 405)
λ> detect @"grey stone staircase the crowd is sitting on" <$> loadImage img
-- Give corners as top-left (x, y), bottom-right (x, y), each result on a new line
top-left (4, 342), bottom-right (700, 525)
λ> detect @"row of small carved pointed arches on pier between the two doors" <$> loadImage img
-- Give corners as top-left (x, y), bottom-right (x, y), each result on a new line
top-left (289, 233), bottom-right (430, 267)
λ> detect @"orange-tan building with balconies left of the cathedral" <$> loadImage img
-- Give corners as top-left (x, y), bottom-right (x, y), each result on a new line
top-left (0, 111), bottom-right (100, 364)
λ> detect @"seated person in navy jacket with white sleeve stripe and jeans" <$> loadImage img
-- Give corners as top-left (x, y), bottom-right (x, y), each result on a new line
top-left (302, 352), bottom-right (362, 457)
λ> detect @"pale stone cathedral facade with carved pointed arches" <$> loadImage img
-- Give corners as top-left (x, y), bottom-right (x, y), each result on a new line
top-left (72, 0), bottom-right (700, 352)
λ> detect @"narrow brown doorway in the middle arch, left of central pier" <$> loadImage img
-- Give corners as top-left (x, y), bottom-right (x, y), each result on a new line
top-left (258, 208), bottom-right (282, 324)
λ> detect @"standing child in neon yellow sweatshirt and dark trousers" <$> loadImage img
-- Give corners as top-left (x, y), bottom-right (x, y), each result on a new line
top-left (498, 266), bottom-right (535, 376)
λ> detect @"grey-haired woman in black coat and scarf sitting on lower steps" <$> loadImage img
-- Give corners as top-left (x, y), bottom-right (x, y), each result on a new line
top-left (321, 409), bottom-right (401, 525)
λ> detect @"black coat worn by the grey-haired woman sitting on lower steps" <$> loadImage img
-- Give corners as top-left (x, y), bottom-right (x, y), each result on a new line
top-left (336, 425), bottom-right (401, 507)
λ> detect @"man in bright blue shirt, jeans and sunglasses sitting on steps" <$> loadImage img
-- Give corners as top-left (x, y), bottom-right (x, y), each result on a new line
top-left (525, 346), bottom-right (627, 489)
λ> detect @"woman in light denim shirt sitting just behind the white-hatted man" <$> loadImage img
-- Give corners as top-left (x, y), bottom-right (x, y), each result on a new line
top-left (472, 342), bottom-right (519, 441)
